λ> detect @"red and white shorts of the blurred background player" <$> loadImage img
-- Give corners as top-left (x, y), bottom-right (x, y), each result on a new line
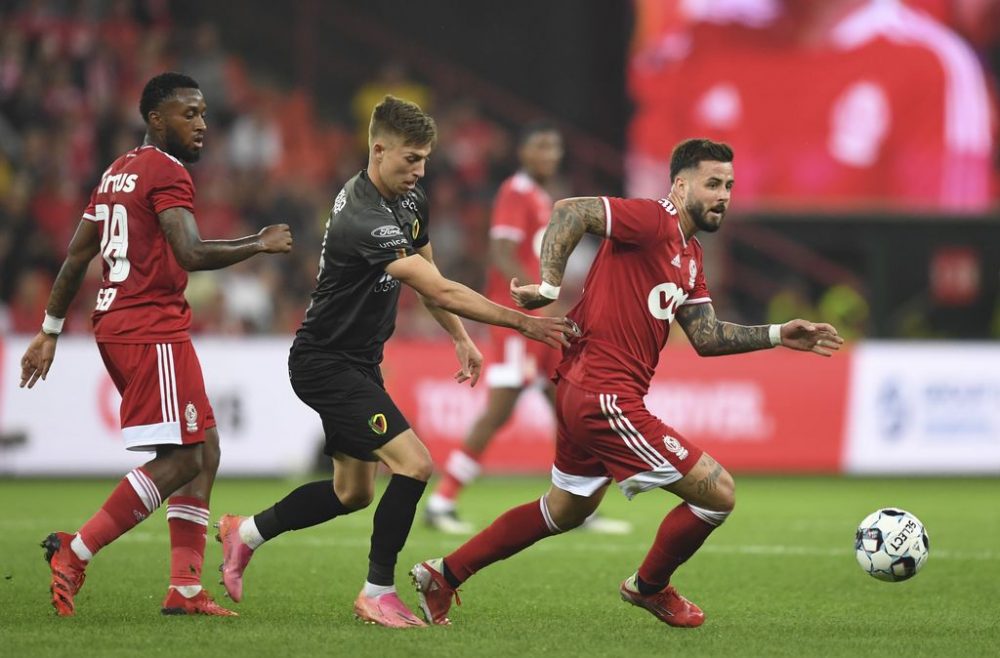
top-left (486, 326), bottom-right (562, 388)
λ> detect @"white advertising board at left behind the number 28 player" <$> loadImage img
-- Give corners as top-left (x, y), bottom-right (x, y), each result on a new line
top-left (0, 336), bottom-right (322, 477)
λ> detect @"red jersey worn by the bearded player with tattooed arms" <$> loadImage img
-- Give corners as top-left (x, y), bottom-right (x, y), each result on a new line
top-left (555, 197), bottom-right (712, 397)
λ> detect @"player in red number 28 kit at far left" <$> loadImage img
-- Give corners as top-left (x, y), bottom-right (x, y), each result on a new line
top-left (21, 73), bottom-right (292, 616)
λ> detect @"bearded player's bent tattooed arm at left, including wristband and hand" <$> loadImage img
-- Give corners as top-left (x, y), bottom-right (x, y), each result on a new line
top-left (510, 197), bottom-right (608, 309)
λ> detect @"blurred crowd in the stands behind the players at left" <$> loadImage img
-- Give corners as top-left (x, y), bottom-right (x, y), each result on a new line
top-left (0, 0), bottom-right (556, 336)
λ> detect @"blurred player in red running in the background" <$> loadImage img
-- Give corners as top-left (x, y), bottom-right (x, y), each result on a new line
top-left (425, 122), bottom-right (631, 534)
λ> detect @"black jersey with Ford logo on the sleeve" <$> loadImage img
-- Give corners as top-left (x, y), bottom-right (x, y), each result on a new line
top-left (292, 171), bottom-right (429, 365)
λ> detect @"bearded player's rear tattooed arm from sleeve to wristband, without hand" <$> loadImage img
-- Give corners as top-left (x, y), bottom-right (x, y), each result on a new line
top-left (541, 197), bottom-right (607, 286)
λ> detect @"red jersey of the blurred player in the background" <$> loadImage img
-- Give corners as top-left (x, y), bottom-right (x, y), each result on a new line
top-left (486, 171), bottom-right (552, 307)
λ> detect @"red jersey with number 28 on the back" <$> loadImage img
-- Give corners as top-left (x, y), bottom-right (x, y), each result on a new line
top-left (83, 145), bottom-right (194, 343)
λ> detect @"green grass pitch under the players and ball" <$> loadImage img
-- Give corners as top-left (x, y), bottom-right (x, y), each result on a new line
top-left (0, 477), bottom-right (1000, 658)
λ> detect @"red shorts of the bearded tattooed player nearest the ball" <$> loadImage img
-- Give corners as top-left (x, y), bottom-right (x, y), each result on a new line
top-left (552, 380), bottom-right (702, 498)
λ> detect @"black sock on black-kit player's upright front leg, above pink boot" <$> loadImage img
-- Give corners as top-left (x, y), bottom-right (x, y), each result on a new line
top-left (368, 475), bottom-right (427, 586)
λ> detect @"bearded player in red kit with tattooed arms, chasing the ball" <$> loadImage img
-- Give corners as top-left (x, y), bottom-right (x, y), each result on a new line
top-left (410, 139), bottom-right (843, 627)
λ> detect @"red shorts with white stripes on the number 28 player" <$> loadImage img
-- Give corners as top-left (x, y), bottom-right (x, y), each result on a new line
top-left (97, 341), bottom-right (215, 451)
